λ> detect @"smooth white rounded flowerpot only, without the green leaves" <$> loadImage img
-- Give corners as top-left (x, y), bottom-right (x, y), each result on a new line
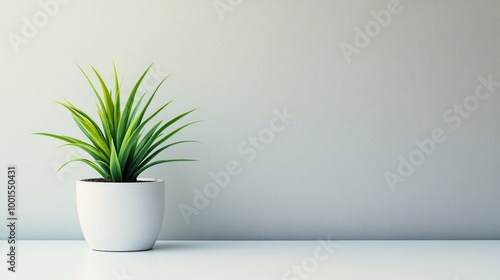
top-left (76, 179), bottom-right (165, 251)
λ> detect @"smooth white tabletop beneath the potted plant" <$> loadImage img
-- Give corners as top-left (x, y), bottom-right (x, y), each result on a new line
top-left (0, 240), bottom-right (500, 280)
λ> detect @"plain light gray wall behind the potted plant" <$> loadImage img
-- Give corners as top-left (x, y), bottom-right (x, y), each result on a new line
top-left (0, 0), bottom-right (500, 239)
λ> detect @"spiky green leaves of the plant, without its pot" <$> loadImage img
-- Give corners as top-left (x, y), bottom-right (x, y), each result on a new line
top-left (35, 65), bottom-right (196, 182)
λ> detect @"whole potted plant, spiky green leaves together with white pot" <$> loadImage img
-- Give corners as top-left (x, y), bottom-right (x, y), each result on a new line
top-left (36, 65), bottom-right (195, 251)
